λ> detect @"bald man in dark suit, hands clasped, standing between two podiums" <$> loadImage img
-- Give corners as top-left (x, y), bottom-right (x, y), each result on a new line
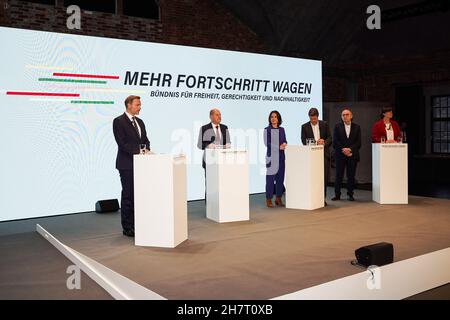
top-left (331, 108), bottom-right (361, 201)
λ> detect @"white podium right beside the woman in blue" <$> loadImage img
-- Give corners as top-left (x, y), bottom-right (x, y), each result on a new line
top-left (285, 145), bottom-right (325, 210)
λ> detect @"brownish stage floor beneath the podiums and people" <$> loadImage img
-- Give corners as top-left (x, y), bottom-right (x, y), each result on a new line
top-left (0, 190), bottom-right (450, 299)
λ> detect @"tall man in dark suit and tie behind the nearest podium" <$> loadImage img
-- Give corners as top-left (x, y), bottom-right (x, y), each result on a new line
top-left (113, 96), bottom-right (150, 237)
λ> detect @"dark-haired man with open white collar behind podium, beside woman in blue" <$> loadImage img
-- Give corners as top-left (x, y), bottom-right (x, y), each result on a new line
top-left (301, 108), bottom-right (332, 205)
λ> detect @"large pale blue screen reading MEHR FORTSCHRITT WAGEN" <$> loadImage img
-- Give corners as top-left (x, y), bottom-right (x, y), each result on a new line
top-left (0, 27), bottom-right (322, 221)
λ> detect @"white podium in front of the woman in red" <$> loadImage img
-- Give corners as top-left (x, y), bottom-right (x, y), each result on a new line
top-left (372, 143), bottom-right (408, 204)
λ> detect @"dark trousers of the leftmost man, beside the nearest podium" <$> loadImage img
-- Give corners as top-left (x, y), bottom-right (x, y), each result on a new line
top-left (119, 170), bottom-right (134, 230)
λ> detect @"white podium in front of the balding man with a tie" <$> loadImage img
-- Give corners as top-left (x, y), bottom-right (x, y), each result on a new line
top-left (205, 149), bottom-right (250, 222)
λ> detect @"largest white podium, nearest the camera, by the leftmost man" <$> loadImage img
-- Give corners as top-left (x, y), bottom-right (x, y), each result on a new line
top-left (134, 154), bottom-right (188, 248)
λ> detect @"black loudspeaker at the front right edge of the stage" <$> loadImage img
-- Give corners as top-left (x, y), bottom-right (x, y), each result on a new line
top-left (355, 242), bottom-right (394, 267)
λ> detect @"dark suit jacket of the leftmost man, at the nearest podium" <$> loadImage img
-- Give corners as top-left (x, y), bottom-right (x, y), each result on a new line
top-left (113, 113), bottom-right (150, 170)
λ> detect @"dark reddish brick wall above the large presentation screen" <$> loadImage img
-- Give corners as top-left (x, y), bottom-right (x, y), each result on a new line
top-left (0, 0), bottom-right (266, 53)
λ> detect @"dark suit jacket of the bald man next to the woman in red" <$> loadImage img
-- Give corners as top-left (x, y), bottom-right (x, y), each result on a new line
top-left (333, 122), bottom-right (361, 161)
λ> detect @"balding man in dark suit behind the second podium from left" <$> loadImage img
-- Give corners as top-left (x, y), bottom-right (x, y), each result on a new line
top-left (197, 109), bottom-right (230, 201)
